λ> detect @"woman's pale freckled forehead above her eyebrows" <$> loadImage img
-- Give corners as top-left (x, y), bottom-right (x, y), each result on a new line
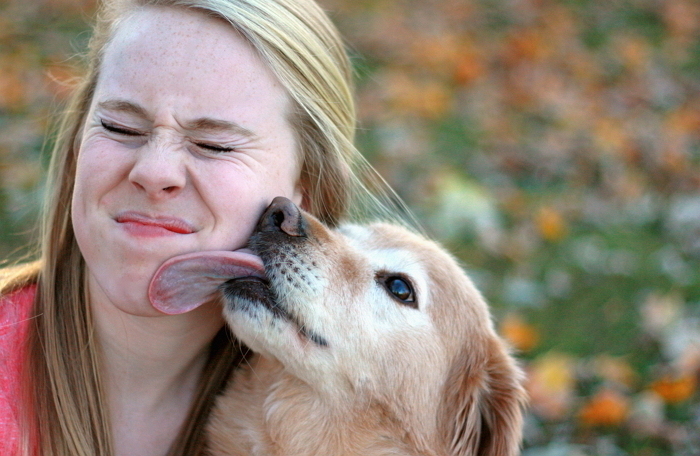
top-left (95, 7), bottom-right (289, 128)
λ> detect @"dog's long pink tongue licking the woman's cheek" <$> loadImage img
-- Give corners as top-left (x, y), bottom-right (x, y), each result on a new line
top-left (148, 250), bottom-right (265, 315)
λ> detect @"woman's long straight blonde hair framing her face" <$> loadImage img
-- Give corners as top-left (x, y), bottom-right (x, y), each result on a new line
top-left (5, 0), bottom-right (402, 456)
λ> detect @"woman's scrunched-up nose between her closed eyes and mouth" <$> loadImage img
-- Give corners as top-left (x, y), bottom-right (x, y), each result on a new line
top-left (129, 137), bottom-right (187, 199)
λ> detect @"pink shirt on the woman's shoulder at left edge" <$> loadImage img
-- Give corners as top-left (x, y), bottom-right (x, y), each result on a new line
top-left (0, 285), bottom-right (36, 456)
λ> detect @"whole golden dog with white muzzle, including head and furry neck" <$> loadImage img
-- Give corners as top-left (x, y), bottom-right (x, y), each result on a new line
top-left (152, 197), bottom-right (526, 456)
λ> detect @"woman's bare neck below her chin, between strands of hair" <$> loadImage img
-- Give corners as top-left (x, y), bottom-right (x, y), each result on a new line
top-left (90, 274), bottom-right (223, 456)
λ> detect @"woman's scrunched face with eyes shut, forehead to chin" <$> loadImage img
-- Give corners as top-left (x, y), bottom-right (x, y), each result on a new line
top-left (72, 8), bottom-right (301, 315)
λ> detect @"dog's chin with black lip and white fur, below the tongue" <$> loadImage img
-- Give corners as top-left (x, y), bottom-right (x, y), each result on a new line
top-left (222, 277), bottom-right (328, 352)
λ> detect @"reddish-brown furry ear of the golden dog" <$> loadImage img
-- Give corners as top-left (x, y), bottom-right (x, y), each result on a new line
top-left (439, 337), bottom-right (526, 456)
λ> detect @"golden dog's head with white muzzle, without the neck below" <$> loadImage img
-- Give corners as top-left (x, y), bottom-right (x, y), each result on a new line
top-left (149, 198), bottom-right (524, 456)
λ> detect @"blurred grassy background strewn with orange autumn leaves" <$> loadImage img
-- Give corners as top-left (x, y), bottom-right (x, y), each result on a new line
top-left (0, 0), bottom-right (700, 456)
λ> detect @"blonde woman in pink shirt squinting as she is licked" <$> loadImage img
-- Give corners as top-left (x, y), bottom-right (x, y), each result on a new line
top-left (0, 0), bottom-right (392, 456)
